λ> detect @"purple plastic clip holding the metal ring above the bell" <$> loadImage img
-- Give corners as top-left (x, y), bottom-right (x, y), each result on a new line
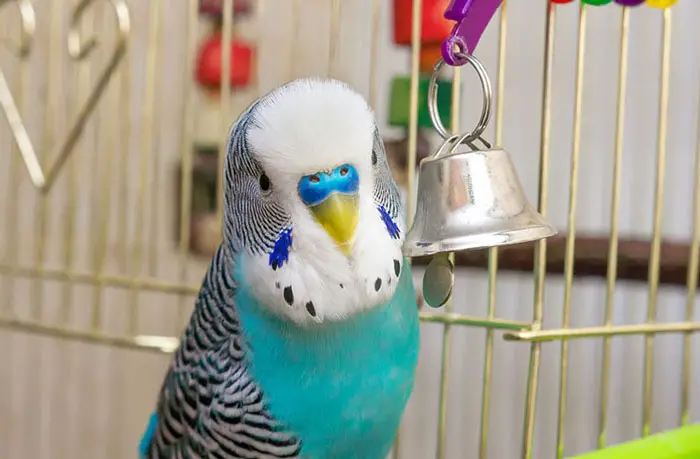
top-left (441, 0), bottom-right (502, 66)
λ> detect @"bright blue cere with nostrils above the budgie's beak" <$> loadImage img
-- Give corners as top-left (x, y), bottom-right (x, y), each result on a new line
top-left (298, 164), bottom-right (360, 206)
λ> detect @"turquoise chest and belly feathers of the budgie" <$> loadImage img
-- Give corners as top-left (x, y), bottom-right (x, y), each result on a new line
top-left (236, 264), bottom-right (418, 459)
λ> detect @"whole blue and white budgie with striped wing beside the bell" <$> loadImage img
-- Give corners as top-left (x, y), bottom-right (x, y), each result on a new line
top-left (141, 79), bottom-right (419, 459)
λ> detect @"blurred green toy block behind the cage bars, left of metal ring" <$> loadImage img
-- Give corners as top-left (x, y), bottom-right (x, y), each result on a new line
top-left (389, 76), bottom-right (452, 131)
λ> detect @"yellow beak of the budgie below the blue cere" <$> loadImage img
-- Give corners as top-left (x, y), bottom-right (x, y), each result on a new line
top-left (309, 193), bottom-right (358, 255)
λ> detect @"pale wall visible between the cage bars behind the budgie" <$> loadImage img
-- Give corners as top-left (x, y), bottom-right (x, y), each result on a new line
top-left (0, 0), bottom-right (700, 459)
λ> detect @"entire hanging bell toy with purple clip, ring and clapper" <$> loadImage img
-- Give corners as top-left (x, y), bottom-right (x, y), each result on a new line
top-left (403, 0), bottom-right (556, 307)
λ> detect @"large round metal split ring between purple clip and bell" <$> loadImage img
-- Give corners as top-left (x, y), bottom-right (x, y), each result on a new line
top-left (428, 52), bottom-right (492, 143)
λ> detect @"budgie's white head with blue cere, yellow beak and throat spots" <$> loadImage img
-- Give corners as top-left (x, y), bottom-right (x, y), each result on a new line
top-left (223, 78), bottom-right (405, 325)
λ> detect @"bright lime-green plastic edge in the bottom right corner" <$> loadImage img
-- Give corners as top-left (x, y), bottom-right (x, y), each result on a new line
top-left (569, 424), bottom-right (700, 459)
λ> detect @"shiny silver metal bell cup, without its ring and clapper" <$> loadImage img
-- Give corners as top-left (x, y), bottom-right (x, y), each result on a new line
top-left (403, 144), bottom-right (556, 257)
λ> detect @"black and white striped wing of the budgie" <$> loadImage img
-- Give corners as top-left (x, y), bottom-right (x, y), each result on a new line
top-left (148, 249), bottom-right (300, 459)
